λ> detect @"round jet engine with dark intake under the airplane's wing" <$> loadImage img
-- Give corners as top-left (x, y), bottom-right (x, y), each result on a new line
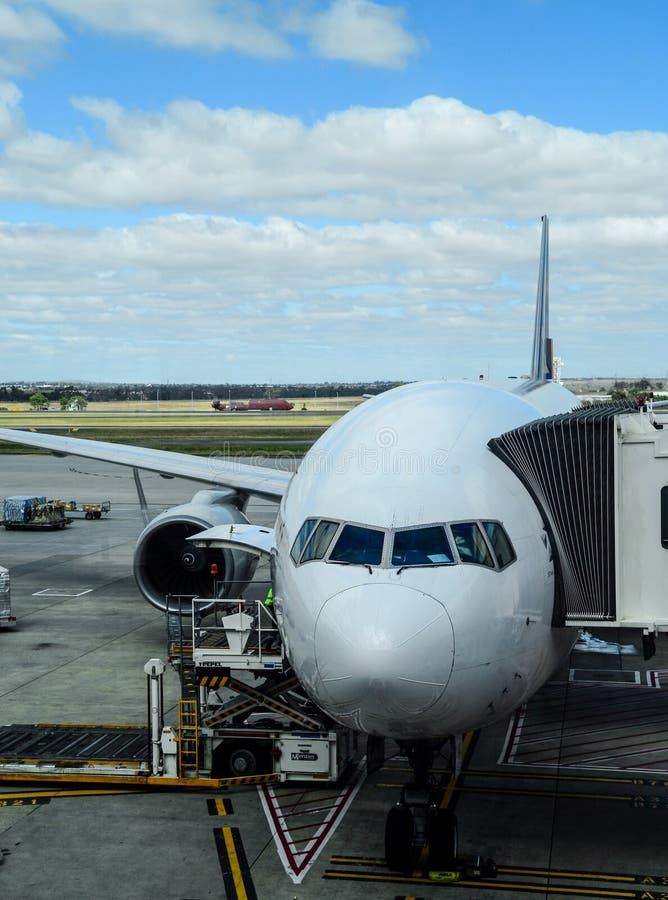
top-left (134, 491), bottom-right (257, 611)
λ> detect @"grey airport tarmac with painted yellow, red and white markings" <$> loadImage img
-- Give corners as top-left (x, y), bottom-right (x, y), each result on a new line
top-left (0, 455), bottom-right (668, 900)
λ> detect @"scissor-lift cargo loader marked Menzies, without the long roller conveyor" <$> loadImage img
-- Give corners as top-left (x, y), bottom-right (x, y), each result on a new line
top-left (168, 592), bottom-right (357, 781)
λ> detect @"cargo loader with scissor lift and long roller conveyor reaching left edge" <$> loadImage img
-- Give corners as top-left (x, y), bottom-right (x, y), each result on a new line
top-left (0, 582), bottom-right (358, 788)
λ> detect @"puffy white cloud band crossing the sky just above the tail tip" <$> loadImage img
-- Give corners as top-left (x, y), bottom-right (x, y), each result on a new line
top-left (0, 94), bottom-right (668, 220)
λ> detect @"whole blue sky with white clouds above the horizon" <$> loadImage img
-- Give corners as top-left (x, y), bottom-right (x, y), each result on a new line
top-left (0, 0), bottom-right (668, 382)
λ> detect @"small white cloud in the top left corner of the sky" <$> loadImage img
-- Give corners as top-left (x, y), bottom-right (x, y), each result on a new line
top-left (0, 0), bottom-right (64, 78)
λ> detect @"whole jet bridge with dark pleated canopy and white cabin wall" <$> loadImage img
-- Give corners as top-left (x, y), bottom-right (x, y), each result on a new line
top-left (488, 403), bottom-right (668, 635)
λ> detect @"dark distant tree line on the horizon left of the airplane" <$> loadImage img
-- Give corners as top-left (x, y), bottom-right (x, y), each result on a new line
top-left (0, 381), bottom-right (398, 408)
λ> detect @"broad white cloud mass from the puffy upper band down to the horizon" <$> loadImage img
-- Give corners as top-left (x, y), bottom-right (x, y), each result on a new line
top-left (0, 84), bottom-right (668, 381)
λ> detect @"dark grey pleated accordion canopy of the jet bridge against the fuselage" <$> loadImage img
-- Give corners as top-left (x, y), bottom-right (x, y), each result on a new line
top-left (488, 402), bottom-right (637, 627)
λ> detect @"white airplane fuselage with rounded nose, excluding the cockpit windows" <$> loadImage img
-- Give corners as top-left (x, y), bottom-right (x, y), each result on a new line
top-left (274, 382), bottom-right (575, 740)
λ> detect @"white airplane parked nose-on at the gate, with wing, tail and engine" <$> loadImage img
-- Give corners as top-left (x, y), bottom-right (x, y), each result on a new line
top-left (0, 216), bottom-right (578, 871)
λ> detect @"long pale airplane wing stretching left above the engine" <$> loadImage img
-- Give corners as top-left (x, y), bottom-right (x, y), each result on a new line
top-left (0, 428), bottom-right (292, 500)
